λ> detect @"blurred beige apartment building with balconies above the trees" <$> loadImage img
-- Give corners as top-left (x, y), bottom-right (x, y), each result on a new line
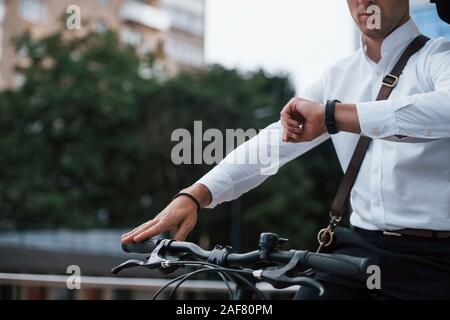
top-left (0, 0), bottom-right (205, 88)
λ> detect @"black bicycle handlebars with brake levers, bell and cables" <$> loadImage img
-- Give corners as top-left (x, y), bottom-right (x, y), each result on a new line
top-left (111, 233), bottom-right (369, 300)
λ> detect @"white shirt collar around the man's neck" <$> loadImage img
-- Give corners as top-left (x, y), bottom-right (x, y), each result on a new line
top-left (360, 19), bottom-right (421, 61)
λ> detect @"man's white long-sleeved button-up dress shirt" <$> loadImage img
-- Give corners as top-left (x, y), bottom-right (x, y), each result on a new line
top-left (197, 20), bottom-right (450, 230)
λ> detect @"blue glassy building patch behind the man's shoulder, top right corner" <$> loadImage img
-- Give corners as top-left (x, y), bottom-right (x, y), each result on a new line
top-left (410, 0), bottom-right (450, 39)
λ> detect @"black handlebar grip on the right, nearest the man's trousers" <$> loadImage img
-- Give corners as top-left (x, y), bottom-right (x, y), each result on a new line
top-left (304, 252), bottom-right (370, 276)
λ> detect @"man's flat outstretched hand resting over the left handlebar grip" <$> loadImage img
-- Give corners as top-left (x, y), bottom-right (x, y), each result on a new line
top-left (122, 184), bottom-right (211, 243)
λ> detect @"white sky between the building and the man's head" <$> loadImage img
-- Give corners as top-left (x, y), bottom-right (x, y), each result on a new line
top-left (205, 0), bottom-right (356, 91)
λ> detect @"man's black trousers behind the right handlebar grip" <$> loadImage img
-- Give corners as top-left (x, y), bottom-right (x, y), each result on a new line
top-left (294, 227), bottom-right (450, 300)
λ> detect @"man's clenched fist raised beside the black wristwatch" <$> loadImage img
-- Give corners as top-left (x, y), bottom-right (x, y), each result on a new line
top-left (280, 98), bottom-right (327, 142)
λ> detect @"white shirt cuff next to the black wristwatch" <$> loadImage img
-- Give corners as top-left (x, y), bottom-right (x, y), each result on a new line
top-left (356, 99), bottom-right (410, 139)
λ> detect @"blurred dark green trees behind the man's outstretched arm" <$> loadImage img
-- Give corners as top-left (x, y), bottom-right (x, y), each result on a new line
top-left (0, 32), bottom-right (339, 249)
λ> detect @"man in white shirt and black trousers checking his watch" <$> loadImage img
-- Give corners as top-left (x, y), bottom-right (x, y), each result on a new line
top-left (122, 0), bottom-right (450, 299)
